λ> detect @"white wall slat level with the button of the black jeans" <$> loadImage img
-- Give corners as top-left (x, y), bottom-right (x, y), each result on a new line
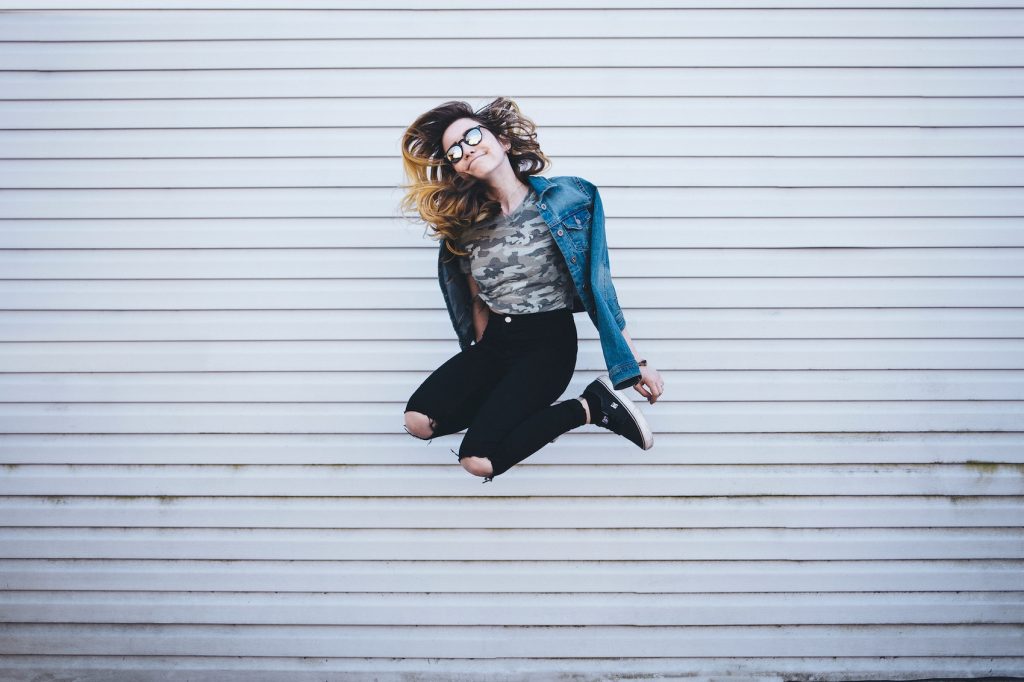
top-left (6, 307), bottom-right (1024, 339)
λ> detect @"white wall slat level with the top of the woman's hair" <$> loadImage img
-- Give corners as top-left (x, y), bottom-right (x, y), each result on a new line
top-left (0, 98), bottom-right (1024, 127)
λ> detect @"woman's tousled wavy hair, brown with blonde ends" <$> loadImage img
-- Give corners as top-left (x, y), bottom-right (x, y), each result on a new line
top-left (401, 97), bottom-right (551, 256)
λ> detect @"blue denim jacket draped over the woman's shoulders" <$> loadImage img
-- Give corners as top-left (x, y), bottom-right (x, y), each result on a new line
top-left (437, 175), bottom-right (640, 388)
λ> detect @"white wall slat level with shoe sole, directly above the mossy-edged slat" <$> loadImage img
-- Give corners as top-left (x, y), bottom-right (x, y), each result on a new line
top-left (0, 427), bottom-right (1024, 464)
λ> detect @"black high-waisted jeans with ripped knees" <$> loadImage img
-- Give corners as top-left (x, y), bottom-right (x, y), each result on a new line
top-left (406, 308), bottom-right (587, 482)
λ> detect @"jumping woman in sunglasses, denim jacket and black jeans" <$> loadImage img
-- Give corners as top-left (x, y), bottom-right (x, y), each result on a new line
top-left (401, 97), bottom-right (665, 482)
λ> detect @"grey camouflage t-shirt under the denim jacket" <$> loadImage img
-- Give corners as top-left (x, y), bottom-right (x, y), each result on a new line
top-left (458, 188), bottom-right (575, 314)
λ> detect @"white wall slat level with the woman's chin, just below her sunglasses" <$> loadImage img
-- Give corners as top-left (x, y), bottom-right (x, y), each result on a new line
top-left (8, 157), bottom-right (1024, 189)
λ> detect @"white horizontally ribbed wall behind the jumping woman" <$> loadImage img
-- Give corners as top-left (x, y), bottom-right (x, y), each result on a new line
top-left (0, 0), bottom-right (1024, 682)
